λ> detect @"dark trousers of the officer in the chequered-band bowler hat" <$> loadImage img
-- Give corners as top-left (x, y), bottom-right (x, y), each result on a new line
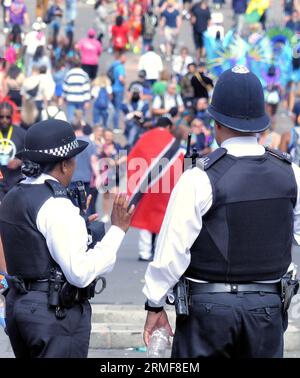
top-left (6, 289), bottom-right (91, 358)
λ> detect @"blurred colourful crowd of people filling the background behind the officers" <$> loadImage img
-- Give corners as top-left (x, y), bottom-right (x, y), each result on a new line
top-left (0, 0), bottom-right (300, 222)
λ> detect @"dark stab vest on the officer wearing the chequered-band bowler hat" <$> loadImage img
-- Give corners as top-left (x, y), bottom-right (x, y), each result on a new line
top-left (0, 180), bottom-right (68, 280)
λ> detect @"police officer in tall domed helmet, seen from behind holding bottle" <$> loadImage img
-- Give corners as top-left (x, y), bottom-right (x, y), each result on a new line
top-left (143, 66), bottom-right (300, 357)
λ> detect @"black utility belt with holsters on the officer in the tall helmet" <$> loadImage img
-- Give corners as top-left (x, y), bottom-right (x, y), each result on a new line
top-left (169, 272), bottom-right (299, 316)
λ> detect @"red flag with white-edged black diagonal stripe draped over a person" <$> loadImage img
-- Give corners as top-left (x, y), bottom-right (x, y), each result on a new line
top-left (127, 127), bottom-right (185, 234)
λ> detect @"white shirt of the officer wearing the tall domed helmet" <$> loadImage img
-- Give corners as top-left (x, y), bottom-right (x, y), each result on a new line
top-left (143, 137), bottom-right (300, 306)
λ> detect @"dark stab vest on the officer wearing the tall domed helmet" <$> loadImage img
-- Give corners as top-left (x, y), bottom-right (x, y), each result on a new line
top-left (185, 149), bottom-right (297, 283)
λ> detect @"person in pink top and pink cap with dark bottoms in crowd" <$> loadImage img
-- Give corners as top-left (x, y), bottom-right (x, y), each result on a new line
top-left (75, 28), bottom-right (102, 80)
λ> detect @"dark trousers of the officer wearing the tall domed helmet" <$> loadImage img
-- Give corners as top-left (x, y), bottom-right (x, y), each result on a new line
top-left (172, 293), bottom-right (287, 358)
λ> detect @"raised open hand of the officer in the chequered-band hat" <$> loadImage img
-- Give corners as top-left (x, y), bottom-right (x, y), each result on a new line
top-left (111, 194), bottom-right (134, 232)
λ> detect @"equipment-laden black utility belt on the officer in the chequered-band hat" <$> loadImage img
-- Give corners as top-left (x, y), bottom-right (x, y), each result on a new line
top-left (8, 268), bottom-right (106, 319)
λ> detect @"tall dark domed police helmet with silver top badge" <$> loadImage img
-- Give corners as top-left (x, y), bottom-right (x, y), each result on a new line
top-left (208, 66), bottom-right (270, 133)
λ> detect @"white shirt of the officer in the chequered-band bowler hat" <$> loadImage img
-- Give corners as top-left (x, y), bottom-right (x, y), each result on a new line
top-left (23, 174), bottom-right (125, 287)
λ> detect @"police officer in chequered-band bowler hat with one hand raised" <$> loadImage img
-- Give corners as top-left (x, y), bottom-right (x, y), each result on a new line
top-left (0, 120), bottom-right (133, 358)
